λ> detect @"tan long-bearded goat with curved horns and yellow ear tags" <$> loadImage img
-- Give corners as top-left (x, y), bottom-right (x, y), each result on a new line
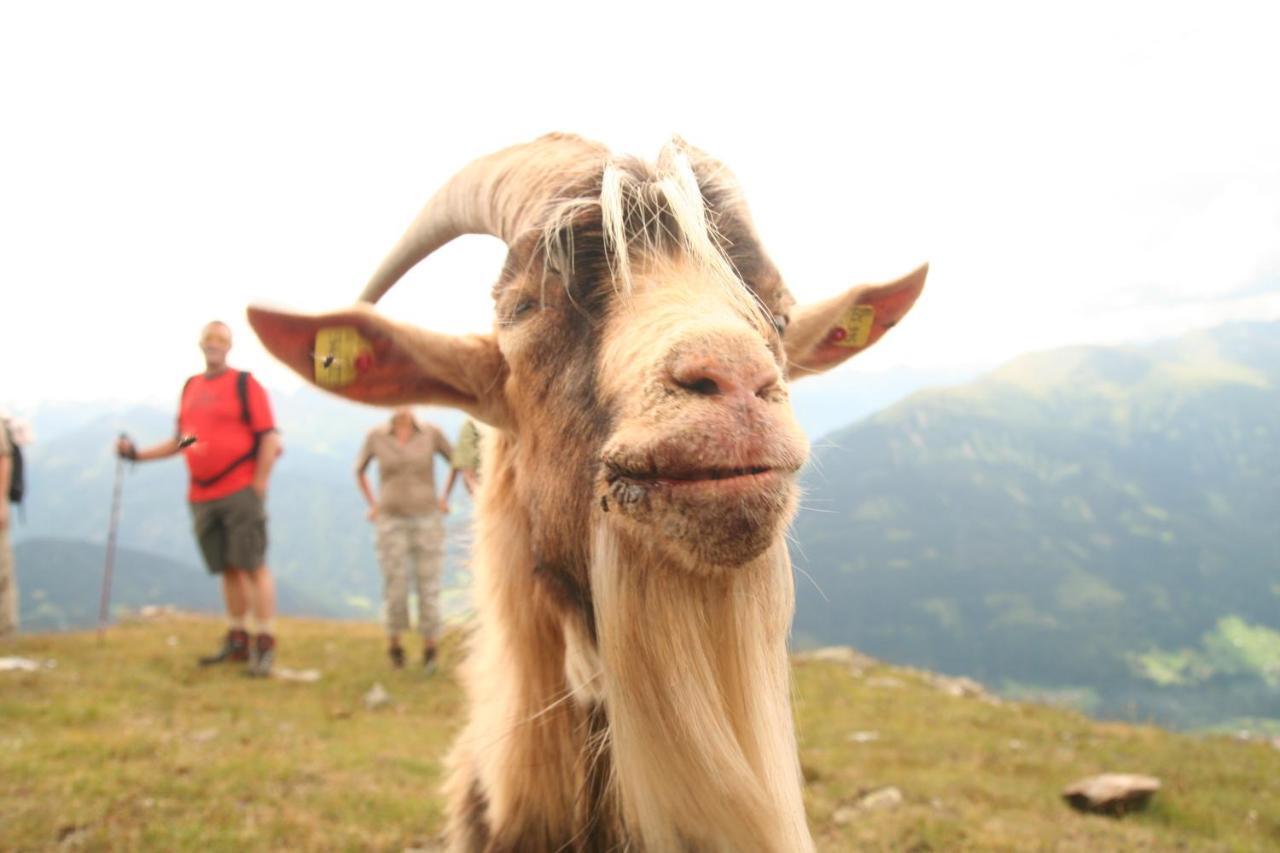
top-left (250, 134), bottom-right (927, 852)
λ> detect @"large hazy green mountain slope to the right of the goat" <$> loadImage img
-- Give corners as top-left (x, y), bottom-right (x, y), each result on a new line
top-left (795, 323), bottom-right (1280, 727)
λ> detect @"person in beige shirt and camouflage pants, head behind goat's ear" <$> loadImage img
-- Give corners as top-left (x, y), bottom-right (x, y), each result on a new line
top-left (356, 406), bottom-right (453, 674)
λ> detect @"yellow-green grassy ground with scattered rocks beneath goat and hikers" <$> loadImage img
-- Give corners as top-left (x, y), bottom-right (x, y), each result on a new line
top-left (0, 616), bottom-right (1280, 850)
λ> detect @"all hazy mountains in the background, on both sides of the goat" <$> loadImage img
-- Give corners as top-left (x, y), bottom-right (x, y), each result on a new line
top-left (5, 323), bottom-right (1280, 725)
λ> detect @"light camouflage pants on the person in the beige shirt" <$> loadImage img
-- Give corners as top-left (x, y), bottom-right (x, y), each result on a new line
top-left (378, 514), bottom-right (444, 639)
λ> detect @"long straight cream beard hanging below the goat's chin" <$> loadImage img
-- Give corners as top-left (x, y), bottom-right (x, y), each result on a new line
top-left (591, 523), bottom-right (813, 852)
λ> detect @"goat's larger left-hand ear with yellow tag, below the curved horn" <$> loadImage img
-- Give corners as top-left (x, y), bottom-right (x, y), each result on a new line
top-left (248, 302), bottom-right (509, 427)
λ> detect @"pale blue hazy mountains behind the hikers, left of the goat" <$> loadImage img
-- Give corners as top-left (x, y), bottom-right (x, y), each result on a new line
top-left (14, 389), bottom-right (470, 617)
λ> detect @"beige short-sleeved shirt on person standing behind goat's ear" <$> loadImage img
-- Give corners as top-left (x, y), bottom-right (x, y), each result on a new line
top-left (356, 424), bottom-right (453, 515)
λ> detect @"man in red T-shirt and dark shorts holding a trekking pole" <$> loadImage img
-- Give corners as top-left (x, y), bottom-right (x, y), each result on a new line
top-left (116, 320), bottom-right (280, 678)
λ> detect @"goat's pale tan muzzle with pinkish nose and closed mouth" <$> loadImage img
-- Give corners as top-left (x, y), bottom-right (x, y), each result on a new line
top-left (594, 259), bottom-right (808, 571)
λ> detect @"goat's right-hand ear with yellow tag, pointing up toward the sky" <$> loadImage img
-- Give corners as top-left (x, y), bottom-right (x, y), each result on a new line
top-left (782, 264), bottom-right (929, 379)
